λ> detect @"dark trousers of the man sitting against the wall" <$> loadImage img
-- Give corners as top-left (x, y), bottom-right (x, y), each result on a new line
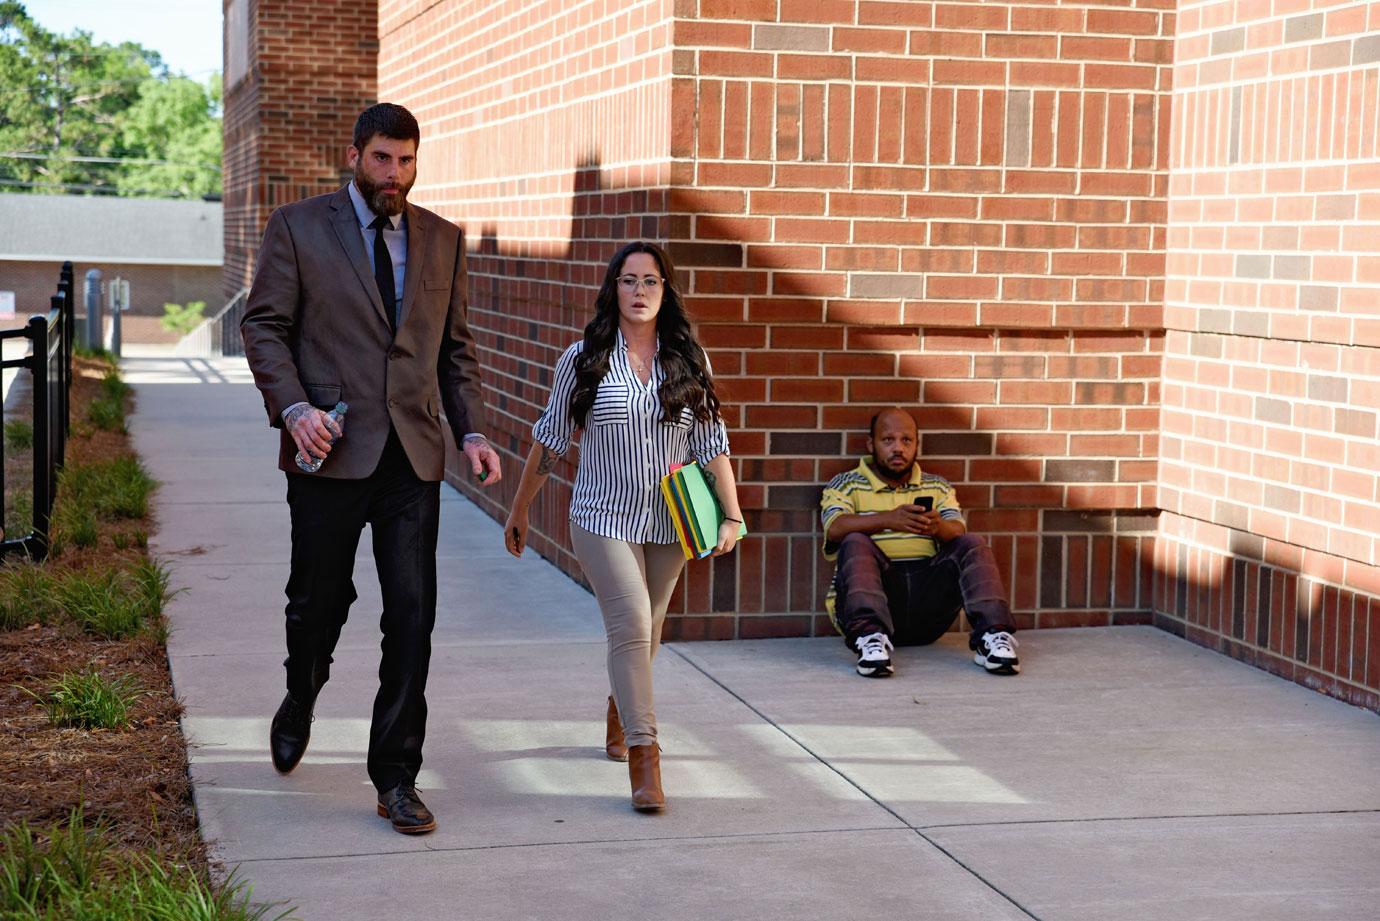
top-left (834, 533), bottom-right (1016, 649)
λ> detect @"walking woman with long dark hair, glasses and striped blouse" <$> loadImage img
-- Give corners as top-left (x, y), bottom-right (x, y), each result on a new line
top-left (504, 242), bottom-right (742, 811)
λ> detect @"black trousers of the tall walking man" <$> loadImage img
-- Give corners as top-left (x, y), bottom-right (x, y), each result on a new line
top-left (283, 432), bottom-right (440, 791)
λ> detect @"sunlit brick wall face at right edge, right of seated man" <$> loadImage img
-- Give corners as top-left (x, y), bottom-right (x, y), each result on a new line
top-left (1155, 0), bottom-right (1380, 708)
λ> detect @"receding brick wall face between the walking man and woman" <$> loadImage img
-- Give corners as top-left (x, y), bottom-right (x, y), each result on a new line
top-left (380, 0), bottom-right (671, 577)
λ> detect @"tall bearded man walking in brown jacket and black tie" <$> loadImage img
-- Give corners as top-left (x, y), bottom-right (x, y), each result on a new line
top-left (240, 104), bottom-right (501, 834)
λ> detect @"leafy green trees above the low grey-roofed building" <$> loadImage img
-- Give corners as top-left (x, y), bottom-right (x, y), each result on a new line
top-left (0, 0), bottom-right (221, 196)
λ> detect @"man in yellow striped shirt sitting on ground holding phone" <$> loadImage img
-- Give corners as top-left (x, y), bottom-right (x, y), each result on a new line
top-left (820, 407), bottom-right (1021, 678)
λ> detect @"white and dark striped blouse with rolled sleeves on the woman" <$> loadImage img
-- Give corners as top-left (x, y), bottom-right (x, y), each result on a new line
top-left (531, 330), bottom-right (729, 544)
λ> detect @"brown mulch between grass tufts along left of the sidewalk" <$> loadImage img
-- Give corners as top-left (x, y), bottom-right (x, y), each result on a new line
top-left (0, 358), bottom-right (206, 869)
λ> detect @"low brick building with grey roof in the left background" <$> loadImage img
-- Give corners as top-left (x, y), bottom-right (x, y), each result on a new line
top-left (0, 195), bottom-right (224, 342)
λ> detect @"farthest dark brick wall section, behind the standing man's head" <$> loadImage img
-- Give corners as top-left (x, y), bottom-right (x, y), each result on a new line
top-left (222, 0), bottom-right (378, 301)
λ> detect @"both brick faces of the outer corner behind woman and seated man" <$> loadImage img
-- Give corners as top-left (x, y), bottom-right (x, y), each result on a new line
top-left (380, 0), bottom-right (1173, 635)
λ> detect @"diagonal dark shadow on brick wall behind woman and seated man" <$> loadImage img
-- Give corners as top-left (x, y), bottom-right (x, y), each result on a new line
top-left (453, 157), bottom-right (1155, 638)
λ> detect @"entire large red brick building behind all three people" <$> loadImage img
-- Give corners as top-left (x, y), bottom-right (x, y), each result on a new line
top-left (225, 0), bottom-right (1380, 708)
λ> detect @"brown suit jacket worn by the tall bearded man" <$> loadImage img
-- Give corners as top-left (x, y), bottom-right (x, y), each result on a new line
top-left (240, 188), bottom-right (484, 481)
